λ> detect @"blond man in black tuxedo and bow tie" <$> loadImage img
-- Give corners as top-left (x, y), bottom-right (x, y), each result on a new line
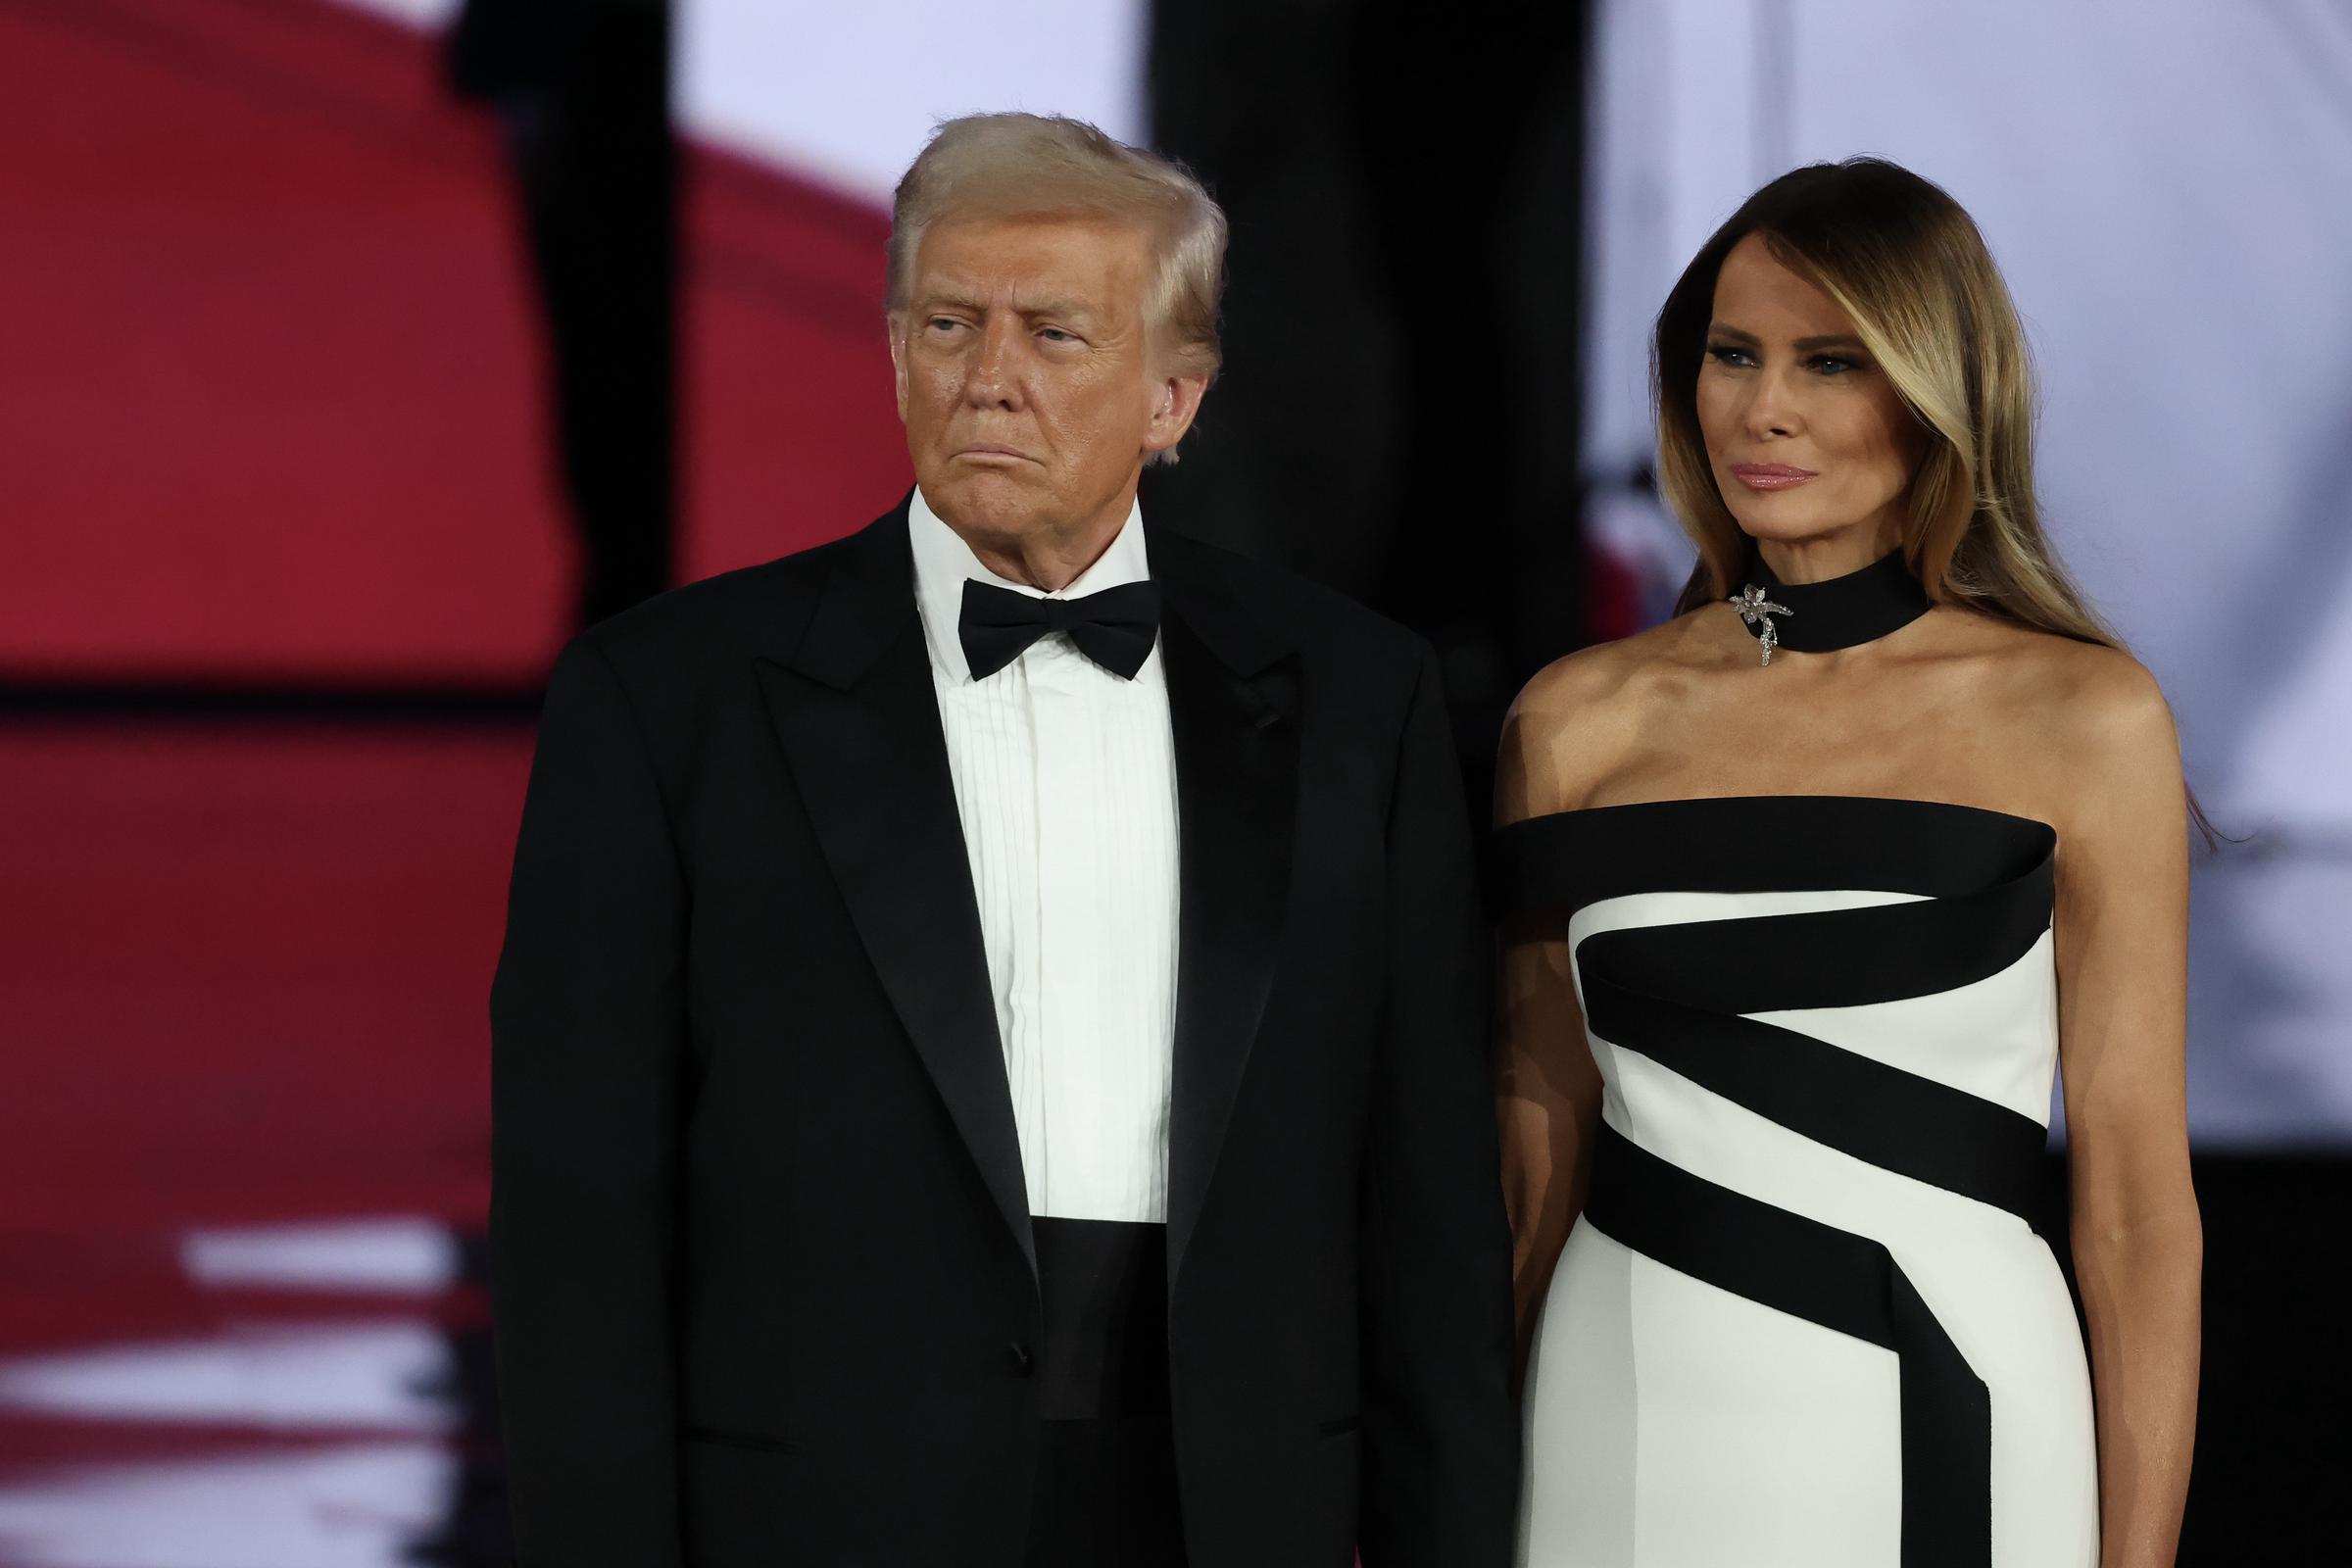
top-left (492, 116), bottom-right (1519, 1568)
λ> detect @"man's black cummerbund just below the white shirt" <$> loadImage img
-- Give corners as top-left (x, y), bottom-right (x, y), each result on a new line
top-left (1030, 1215), bottom-right (1169, 1420)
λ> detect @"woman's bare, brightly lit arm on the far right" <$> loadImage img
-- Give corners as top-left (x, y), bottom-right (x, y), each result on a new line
top-left (2058, 661), bottom-right (2204, 1568)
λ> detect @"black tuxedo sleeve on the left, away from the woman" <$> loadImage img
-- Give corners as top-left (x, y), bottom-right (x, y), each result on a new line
top-left (489, 642), bottom-right (687, 1568)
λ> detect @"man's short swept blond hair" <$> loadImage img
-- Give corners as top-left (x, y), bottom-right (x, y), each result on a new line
top-left (884, 113), bottom-right (1225, 464)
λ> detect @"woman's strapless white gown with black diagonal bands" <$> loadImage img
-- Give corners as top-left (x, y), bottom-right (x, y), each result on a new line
top-left (1495, 797), bottom-right (2098, 1568)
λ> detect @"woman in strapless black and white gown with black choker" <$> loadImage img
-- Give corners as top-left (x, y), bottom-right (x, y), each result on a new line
top-left (1495, 160), bottom-right (2201, 1568)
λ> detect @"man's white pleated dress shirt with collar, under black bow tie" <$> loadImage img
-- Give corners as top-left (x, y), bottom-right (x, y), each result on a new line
top-left (907, 489), bottom-right (1178, 1222)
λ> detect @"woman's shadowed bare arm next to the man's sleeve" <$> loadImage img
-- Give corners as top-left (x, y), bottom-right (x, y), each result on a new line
top-left (1494, 661), bottom-right (1601, 1371)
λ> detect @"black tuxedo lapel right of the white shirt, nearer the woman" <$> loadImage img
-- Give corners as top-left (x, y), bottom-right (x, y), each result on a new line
top-left (1151, 531), bottom-right (1298, 1284)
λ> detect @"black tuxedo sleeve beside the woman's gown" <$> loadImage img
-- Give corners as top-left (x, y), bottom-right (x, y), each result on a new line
top-left (1359, 651), bottom-right (1519, 1568)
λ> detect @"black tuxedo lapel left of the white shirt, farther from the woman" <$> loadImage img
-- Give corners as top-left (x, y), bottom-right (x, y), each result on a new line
top-left (758, 508), bottom-right (1037, 1272)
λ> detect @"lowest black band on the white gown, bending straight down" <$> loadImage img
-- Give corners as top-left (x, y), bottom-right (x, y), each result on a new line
top-left (1583, 1124), bottom-right (1992, 1568)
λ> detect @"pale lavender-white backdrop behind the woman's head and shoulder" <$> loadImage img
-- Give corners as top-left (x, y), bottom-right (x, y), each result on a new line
top-left (1586, 0), bottom-right (2352, 1148)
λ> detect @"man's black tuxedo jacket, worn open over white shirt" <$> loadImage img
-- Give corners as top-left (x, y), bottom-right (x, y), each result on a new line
top-left (492, 508), bottom-right (1519, 1568)
